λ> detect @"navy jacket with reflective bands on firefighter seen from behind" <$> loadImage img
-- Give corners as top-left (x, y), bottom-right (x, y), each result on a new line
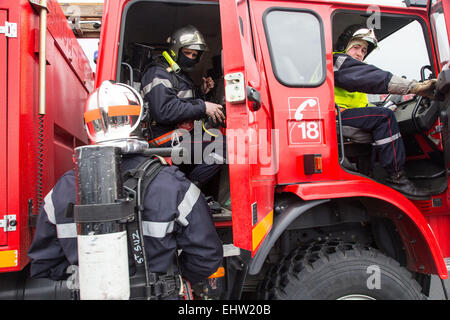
top-left (28, 156), bottom-right (223, 283)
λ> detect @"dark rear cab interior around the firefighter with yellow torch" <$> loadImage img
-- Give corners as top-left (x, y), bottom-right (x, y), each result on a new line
top-left (116, 0), bottom-right (231, 208)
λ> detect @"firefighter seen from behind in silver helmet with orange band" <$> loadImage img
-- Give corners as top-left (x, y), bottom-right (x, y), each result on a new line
top-left (28, 81), bottom-right (223, 299)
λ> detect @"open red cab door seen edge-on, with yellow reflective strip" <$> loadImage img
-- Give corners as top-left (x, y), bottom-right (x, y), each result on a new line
top-left (220, 0), bottom-right (277, 256)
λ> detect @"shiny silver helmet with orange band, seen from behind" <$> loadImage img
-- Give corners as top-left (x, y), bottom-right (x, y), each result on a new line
top-left (84, 81), bottom-right (148, 153)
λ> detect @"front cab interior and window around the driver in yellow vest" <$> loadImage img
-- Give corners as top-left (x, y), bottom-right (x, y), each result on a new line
top-left (332, 11), bottom-right (447, 200)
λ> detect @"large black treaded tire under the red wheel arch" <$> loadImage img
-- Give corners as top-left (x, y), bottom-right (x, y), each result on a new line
top-left (259, 241), bottom-right (425, 300)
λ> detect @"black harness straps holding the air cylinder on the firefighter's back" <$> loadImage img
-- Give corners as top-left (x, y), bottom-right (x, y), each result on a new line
top-left (71, 151), bottom-right (192, 300)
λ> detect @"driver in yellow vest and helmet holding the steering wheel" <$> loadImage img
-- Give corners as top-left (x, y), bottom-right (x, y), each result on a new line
top-left (333, 28), bottom-right (436, 197)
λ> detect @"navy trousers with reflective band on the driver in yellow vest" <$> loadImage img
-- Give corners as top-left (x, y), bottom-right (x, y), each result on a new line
top-left (341, 107), bottom-right (405, 174)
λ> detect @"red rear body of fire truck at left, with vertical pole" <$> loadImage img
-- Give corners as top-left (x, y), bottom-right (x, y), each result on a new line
top-left (0, 0), bottom-right (94, 284)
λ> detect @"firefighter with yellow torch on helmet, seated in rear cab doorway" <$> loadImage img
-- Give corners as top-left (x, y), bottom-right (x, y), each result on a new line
top-left (141, 25), bottom-right (225, 189)
